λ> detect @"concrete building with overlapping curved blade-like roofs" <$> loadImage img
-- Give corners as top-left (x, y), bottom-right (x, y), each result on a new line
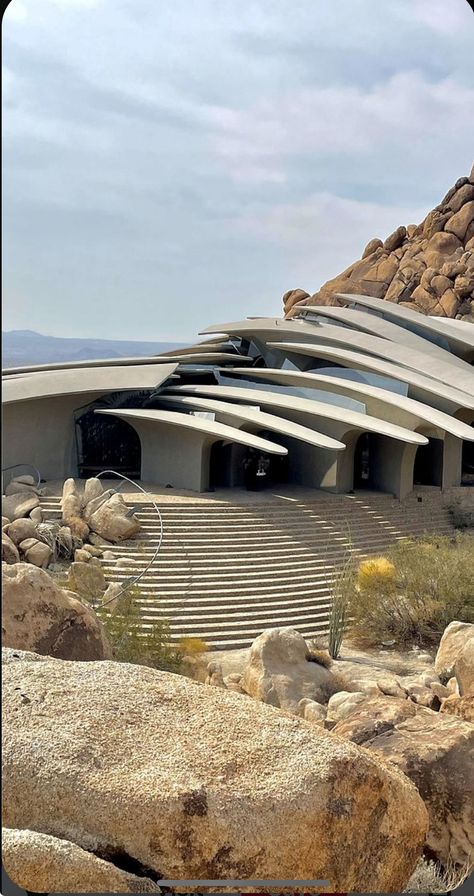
top-left (3, 295), bottom-right (474, 499)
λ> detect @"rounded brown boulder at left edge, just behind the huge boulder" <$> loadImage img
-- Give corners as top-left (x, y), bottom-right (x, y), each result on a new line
top-left (2, 563), bottom-right (112, 660)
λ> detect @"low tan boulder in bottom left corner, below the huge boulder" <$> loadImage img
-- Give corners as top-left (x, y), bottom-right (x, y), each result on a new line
top-left (2, 828), bottom-right (160, 893)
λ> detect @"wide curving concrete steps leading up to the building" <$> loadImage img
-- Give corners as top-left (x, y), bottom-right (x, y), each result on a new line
top-left (42, 489), bottom-right (453, 649)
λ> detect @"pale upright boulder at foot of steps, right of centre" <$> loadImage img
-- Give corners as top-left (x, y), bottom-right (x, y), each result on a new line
top-left (242, 628), bottom-right (340, 715)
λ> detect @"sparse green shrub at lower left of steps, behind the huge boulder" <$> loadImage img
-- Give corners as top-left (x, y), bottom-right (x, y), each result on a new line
top-left (97, 586), bottom-right (183, 672)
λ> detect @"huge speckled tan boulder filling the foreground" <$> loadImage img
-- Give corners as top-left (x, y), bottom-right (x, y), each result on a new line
top-left (2, 651), bottom-right (427, 892)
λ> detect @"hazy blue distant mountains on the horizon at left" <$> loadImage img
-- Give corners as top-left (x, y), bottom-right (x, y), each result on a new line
top-left (2, 330), bottom-right (185, 368)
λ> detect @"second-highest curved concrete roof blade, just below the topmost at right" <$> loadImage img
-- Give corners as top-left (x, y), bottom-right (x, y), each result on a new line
top-left (298, 305), bottom-right (465, 369)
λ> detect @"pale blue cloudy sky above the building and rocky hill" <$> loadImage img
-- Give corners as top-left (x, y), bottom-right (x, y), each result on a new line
top-left (3, 0), bottom-right (474, 341)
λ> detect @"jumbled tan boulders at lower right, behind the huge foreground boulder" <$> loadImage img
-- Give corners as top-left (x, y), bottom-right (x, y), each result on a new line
top-left (207, 622), bottom-right (474, 868)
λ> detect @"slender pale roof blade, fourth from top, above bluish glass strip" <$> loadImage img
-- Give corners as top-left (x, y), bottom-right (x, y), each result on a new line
top-left (268, 342), bottom-right (474, 408)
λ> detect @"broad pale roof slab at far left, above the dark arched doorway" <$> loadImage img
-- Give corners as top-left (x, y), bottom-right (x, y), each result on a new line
top-left (2, 364), bottom-right (178, 404)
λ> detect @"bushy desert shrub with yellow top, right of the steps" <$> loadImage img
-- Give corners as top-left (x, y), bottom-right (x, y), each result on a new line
top-left (349, 533), bottom-right (474, 647)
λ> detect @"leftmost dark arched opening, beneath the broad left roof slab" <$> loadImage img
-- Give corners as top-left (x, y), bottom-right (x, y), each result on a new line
top-left (76, 408), bottom-right (142, 479)
